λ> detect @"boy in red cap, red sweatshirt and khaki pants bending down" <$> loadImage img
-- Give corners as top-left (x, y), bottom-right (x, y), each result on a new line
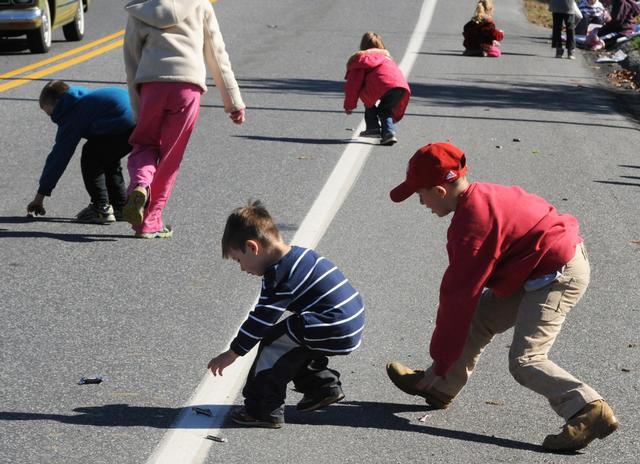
top-left (387, 143), bottom-right (619, 451)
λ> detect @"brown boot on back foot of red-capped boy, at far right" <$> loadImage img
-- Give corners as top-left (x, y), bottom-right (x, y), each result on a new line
top-left (542, 400), bottom-right (620, 451)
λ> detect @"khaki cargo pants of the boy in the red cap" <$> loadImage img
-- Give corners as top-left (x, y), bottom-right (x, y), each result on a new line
top-left (425, 244), bottom-right (602, 420)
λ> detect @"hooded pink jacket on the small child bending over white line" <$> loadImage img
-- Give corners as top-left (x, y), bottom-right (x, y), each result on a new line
top-left (343, 48), bottom-right (411, 122)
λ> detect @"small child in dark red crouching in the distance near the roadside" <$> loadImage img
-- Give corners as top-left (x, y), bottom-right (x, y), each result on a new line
top-left (462, 0), bottom-right (504, 58)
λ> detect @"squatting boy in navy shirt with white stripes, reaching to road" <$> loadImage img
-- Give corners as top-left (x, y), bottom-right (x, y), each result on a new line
top-left (208, 201), bottom-right (364, 428)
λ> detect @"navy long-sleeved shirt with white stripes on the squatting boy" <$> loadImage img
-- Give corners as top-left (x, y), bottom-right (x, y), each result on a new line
top-left (231, 246), bottom-right (364, 356)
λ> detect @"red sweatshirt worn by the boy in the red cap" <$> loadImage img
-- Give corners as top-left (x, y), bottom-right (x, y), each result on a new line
top-left (430, 183), bottom-right (582, 376)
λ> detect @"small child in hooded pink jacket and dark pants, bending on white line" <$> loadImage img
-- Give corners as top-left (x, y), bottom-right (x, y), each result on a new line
top-left (344, 32), bottom-right (411, 145)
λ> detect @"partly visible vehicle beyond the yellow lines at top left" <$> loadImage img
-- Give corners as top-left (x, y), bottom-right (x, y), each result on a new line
top-left (0, 0), bottom-right (90, 53)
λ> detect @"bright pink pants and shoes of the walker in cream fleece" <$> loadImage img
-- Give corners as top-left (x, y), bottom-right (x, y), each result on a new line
top-left (134, 83), bottom-right (202, 233)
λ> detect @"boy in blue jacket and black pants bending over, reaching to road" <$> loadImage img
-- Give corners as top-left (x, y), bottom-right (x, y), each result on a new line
top-left (27, 81), bottom-right (135, 224)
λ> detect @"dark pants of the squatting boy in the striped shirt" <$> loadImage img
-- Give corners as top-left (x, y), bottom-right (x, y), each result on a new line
top-left (242, 316), bottom-right (342, 420)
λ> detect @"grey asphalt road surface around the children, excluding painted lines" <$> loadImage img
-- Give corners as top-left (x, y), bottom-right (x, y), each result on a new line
top-left (0, 0), bottom-right (640, 464)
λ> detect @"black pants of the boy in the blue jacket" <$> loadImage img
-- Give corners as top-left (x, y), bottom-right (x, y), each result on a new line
top-left (80, 131), bottom-right (131, 209)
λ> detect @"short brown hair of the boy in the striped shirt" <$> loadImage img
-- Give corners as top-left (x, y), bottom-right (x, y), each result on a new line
top-left (222, 200), bottom-right (282, 259)
